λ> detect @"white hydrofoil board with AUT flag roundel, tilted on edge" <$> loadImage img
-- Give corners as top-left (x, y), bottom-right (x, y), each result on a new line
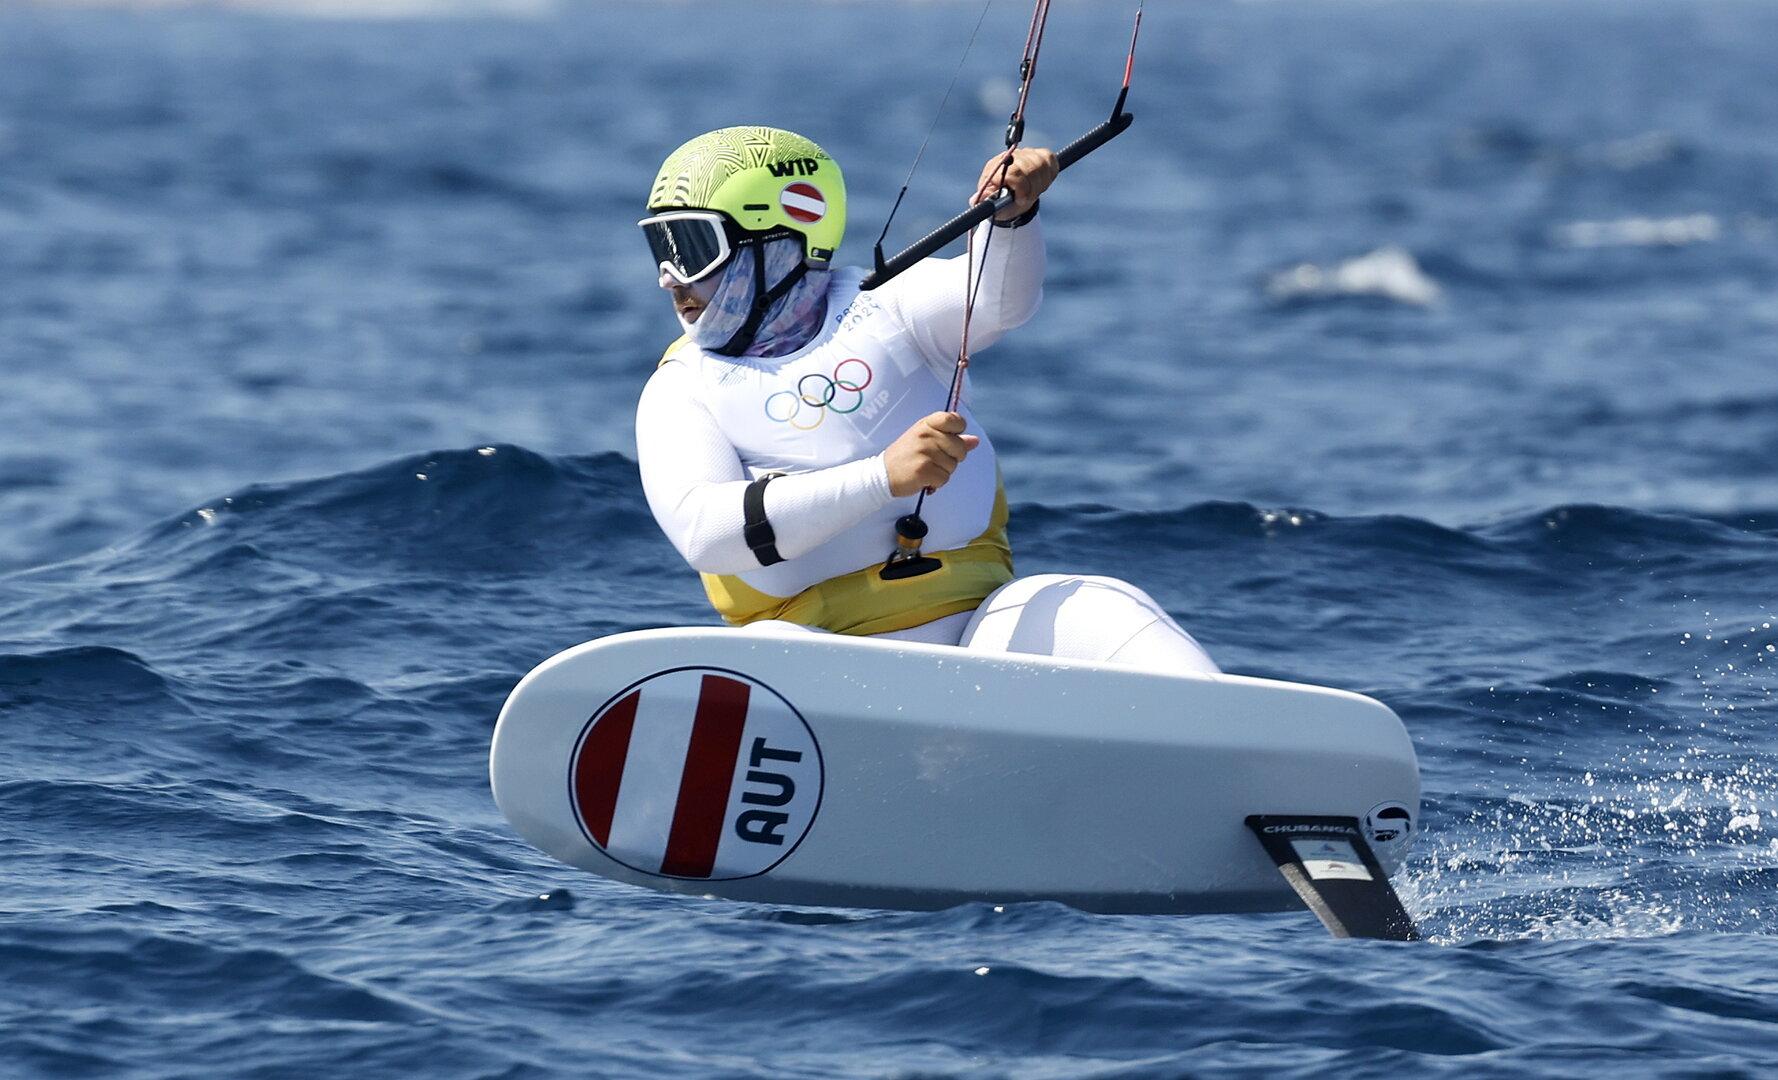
top-left (489, 628), bottom-right (1421, 913)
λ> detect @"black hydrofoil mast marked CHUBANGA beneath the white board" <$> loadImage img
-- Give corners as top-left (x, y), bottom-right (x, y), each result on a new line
top-left (1246, 813), bottom-right (1421, 941)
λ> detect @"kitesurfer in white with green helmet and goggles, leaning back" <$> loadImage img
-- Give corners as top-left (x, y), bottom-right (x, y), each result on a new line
top-left (637, 126), bottom-right (1218, 673)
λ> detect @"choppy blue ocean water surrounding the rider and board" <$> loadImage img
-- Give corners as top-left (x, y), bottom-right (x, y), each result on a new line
top-left (0, 0), bottom-right (1778, 1076)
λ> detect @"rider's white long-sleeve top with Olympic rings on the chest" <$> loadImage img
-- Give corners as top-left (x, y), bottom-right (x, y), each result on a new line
top-left (637, 219), bottom-right (1044, 598)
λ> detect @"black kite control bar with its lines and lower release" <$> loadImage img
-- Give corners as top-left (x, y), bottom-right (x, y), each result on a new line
top-left (861, 0), bottom-right (1141, 580)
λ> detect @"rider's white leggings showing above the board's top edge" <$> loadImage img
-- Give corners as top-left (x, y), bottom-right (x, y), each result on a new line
top-left (745, 573), bottom-right (1221, 674)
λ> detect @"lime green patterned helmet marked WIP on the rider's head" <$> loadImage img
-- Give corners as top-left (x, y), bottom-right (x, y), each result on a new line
top-left (649, 128), bottom-right (846, 269)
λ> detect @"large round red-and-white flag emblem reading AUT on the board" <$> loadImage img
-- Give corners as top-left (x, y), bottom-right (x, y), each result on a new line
top-left (569, 667), bottom-right (821, 879)
